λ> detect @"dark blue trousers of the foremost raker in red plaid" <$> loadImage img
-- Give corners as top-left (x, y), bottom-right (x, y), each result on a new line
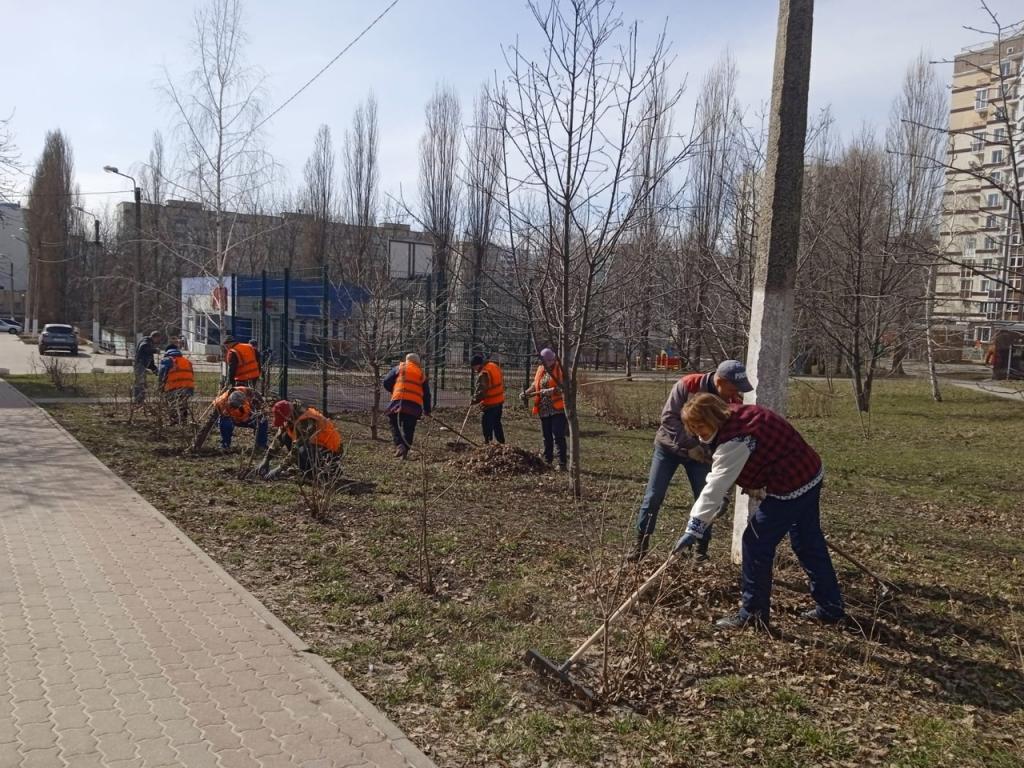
top-left (739, 482), bottom-right (844, 622)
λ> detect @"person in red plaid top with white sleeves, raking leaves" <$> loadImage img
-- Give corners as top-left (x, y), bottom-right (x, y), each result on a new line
top-left (674, 393), bottom-right (846, 629)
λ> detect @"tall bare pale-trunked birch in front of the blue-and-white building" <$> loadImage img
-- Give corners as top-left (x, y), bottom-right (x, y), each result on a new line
top-left (164, 0), bottom-right (270, 339)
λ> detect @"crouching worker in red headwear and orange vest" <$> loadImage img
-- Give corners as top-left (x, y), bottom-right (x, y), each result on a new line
top-left (256, 400), bottom-right (344, 480)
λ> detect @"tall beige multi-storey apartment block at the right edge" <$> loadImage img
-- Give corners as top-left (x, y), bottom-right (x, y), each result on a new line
top-left (934, 29), bottom-right (1024, 342)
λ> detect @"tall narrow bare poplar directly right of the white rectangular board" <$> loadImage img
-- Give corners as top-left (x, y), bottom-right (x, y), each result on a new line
top-left (420, 85), bottom-right (462, 386)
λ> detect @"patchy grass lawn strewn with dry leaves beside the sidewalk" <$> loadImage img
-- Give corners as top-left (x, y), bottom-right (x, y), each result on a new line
top-left (36, 377), bottom-right (1024, 768)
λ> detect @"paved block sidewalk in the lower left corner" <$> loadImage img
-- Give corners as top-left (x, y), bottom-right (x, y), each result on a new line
top-left (0, 382), bottom-right (433, 768)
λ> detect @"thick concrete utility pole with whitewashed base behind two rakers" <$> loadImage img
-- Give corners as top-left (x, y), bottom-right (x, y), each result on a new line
top-left (732, 0), bottom-right (814, 563)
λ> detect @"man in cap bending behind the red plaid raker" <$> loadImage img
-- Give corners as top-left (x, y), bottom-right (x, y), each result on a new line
top-left (627, 360), bottom-right (754, 562)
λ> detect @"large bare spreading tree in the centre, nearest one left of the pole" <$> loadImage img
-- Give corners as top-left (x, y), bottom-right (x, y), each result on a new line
top-left (500, 0), bottom-right (684, 497)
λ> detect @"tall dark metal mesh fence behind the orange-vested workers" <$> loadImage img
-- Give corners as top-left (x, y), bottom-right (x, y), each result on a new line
top-left (206, 268), bottom-right (537, 413)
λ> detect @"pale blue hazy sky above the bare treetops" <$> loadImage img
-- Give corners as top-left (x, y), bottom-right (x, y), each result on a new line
top-left (0, 0), bottom-right (1024, 219)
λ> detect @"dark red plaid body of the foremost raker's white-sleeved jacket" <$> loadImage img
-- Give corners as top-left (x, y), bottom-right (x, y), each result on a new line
top-left (715, 404), bottom-right (821, 496)
